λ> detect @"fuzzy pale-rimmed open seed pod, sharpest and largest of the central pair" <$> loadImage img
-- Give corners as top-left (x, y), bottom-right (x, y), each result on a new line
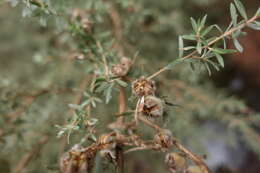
top-left (140, 95), bottom-right (163, 118)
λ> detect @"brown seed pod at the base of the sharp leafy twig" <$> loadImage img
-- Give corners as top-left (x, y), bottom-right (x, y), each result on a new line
top-left (132, 76), bottom-right (156, 97)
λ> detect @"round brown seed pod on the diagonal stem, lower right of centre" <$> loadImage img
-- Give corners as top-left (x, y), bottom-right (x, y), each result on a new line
top-left (154, 129), bottom-right (173, 149)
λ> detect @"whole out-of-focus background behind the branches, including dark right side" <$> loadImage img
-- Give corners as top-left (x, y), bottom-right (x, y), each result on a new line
top-left (0, 0), bottom-right (260, 173)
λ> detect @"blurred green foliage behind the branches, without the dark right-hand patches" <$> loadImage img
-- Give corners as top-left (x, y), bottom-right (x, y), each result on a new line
top-left (0, 0), bottom-right (260, 173)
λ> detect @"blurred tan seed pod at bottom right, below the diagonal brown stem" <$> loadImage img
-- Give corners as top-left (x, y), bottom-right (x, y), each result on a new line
top-left (165, 152), bottom-right (186, 173)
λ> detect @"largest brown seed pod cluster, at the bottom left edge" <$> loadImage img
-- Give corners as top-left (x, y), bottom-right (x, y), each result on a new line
top-left (60, 145), bottom-right (96, 173)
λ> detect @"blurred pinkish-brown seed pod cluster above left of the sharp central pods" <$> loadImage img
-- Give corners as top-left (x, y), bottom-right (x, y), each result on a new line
top-left (111, 57), bottom-right (132, 77)
